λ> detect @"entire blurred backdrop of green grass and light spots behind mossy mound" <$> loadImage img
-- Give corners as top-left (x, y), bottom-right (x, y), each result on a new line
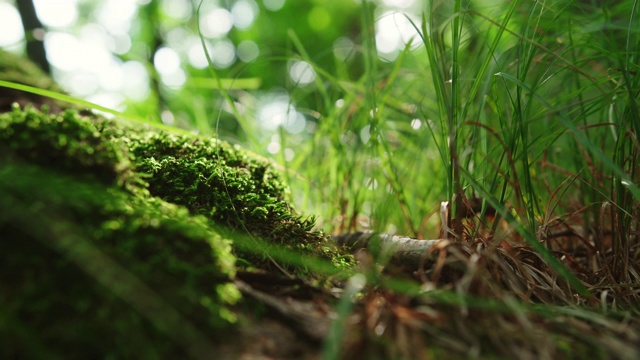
top-left (0, 0), bottom-right (640, 238)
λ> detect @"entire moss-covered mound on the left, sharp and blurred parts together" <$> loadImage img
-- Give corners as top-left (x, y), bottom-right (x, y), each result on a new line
top-left (0, 52), bottom-right (348, 358)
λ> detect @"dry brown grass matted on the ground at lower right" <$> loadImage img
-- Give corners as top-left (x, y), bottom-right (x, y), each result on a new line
top-left (342, 201), bottom-right (640, 359)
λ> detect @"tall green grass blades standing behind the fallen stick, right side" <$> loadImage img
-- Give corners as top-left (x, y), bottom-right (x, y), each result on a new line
top-left (262, 0), bottom-right (638, 272)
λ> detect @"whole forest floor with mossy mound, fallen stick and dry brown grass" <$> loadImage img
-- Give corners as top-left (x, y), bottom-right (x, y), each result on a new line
top-left (0, 50), bottom-right (640, 359)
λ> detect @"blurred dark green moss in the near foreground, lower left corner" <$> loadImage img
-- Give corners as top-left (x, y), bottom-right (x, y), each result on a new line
top-left (0, 162), bottom-right (238, 358)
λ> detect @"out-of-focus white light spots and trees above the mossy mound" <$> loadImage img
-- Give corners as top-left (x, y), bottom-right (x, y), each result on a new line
top-left (0, 0), bottom-right (421, 138)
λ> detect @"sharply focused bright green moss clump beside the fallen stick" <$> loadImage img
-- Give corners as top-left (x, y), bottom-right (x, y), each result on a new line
top-left (97, 116), bottom-right (351, 267)
